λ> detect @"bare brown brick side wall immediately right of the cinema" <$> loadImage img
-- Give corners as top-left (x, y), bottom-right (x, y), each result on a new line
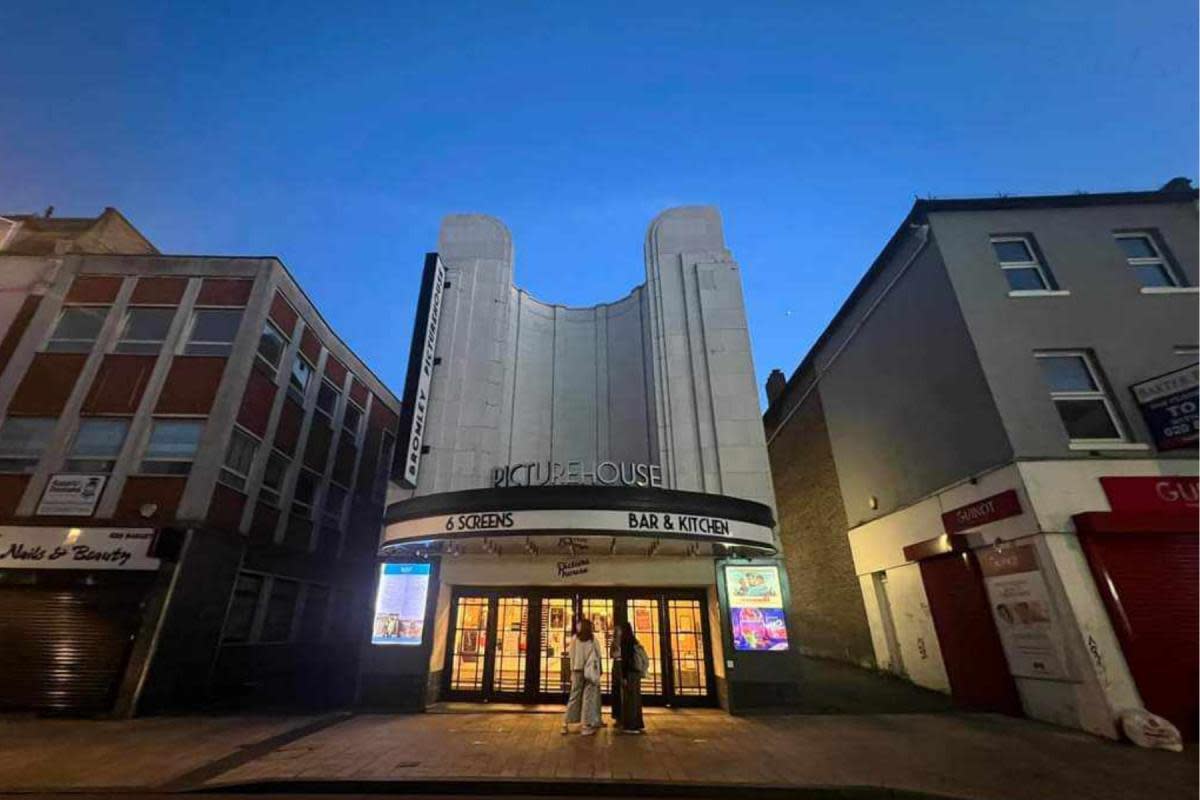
top-left (768, 391), bottom-right (875, 667)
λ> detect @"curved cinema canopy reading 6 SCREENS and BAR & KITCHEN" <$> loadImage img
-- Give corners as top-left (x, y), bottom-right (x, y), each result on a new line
top-left (380, 486), bottom-right (776, 557)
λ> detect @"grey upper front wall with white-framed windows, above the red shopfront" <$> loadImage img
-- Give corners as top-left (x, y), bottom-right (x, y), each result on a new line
top-left (930, 203), bottom-right (1198, 458)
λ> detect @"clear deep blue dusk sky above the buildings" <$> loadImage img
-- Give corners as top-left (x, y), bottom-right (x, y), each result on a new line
top-left (0, 0), bottom-right (1198, 407)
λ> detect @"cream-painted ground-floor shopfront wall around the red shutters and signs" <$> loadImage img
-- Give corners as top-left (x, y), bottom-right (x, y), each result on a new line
top-left (850, 459), bottom-right (1200, 738)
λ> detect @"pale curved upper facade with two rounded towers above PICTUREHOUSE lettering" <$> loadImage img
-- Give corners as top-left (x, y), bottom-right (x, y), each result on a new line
top-left (414, 206), bottom-right (774, 509)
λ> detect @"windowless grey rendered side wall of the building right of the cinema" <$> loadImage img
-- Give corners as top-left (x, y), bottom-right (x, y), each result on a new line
top-left (815, 230), bottom-right (1010, 527)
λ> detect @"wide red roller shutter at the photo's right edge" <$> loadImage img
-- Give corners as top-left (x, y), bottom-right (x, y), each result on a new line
top-left (1079, 527), bottom-right (1200, 739)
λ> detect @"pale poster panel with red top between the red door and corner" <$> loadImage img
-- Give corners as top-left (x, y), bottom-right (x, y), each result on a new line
top-left (978, 545), bottom-right (1070, 680)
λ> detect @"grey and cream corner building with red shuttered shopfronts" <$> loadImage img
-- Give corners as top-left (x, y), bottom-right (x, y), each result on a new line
top-left (763, 181), bottom-right (1198, 736)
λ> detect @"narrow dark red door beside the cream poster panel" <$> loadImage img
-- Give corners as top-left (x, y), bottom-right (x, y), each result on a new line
top-left (920, 553), bottom-right (1022, 716)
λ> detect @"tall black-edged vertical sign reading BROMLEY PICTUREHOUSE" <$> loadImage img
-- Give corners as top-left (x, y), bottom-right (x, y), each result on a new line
top-left (397, 253), bottom-right (446, 489)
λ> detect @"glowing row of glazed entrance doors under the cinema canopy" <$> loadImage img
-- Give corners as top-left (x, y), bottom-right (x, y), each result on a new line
top-left (444, 589), bottom-right (715, 705)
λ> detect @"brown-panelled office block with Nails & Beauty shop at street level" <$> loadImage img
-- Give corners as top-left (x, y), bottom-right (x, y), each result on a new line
top-left (0, 210), bottom-right (400, 714)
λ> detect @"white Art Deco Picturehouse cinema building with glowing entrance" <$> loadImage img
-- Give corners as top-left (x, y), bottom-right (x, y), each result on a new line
top-left (360, 206), bottom-right (797, 711)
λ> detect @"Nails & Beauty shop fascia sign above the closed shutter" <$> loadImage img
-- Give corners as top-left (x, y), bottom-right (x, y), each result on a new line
top-left (0, 525), bottom-right (158, 570)
